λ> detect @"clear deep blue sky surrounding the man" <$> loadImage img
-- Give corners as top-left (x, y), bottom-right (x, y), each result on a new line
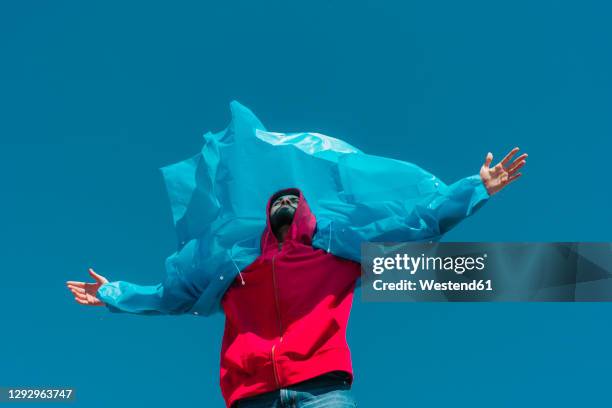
top-left (0, 0), bottom-right (612, 408)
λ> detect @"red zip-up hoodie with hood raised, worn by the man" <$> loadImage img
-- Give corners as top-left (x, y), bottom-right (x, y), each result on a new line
top-left (221, 189), bottom-right (361, 407)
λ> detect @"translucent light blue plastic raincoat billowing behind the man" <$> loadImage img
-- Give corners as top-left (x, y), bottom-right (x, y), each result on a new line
top-left (98, 101), bottom-right (489, 315)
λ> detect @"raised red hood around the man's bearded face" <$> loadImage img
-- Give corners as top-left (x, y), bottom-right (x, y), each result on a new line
top-left (261, 188), bottom-right (317, 253)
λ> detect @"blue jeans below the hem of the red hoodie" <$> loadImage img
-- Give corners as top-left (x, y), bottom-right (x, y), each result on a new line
top-left (232, 371), bottom-right (357, 408)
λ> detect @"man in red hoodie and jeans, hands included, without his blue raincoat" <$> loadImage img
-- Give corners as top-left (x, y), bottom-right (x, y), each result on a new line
top-left (68, 148), bottom-right (527, 408)
